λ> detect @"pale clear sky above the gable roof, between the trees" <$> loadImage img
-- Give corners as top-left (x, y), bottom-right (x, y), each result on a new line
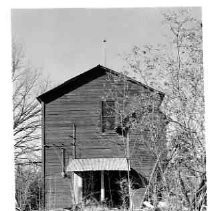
top-left (12, 8), bottom-right (201, 84)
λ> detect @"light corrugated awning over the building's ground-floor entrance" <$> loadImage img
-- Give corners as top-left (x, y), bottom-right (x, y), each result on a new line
top-left (66, 158), bottom-right (128, 171)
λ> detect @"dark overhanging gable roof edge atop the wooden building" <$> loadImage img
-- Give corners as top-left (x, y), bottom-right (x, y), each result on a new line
top-left (37, 64), bottom-right (165, 103)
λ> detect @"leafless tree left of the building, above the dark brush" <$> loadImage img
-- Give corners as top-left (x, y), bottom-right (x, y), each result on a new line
top-left (12, 40), bottom-right (49, 164)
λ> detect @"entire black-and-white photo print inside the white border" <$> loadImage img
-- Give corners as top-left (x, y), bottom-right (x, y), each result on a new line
top-left (11, 7), bottom-right (207, 211)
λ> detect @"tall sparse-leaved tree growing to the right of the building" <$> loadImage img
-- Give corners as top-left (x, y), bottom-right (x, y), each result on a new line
top-left (125, 9), bottom-right (206, 210)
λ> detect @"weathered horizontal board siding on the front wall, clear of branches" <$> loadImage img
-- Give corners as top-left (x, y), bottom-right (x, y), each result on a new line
top-left (44, 71), bottom-right (167, 209)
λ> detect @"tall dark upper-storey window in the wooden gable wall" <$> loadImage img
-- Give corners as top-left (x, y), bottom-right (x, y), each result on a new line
top-left (102, 100), bottom-right (115, 132)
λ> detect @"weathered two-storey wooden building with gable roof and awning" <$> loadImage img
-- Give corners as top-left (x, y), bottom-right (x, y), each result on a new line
top-left (38, 65), bottom-right (167, 210)
